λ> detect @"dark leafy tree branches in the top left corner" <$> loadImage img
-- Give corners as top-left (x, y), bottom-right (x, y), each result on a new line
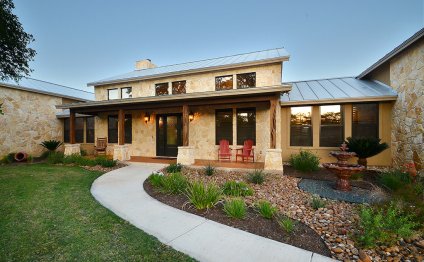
top-left (0, 0), bottom-right (36, 81)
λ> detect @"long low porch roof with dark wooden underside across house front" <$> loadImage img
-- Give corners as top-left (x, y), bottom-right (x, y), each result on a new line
top-left (56, 84), bottom-right (291, 113)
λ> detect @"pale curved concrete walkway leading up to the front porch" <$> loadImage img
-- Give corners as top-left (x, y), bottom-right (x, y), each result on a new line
top-left (91, 163), bottom-right (332, 262)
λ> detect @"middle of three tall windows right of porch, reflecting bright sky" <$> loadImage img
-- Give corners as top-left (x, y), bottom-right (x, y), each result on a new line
top-left (319, 105), bottom-right (344, 147)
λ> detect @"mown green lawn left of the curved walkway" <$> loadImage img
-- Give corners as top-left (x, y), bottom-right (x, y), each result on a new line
top-left (0, 164), bottom-right (191, 261)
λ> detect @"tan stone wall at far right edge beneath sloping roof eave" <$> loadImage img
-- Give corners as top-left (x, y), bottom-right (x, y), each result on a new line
top-left (390, 39), bottom-right (424, 170)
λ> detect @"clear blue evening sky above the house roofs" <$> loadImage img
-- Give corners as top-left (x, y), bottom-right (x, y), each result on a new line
top-left (14, 0), bottom-right (424, 90)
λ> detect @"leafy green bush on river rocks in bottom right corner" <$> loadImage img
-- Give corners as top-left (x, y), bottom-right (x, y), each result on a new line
top-left (357, 202), bottom-right (418, 247)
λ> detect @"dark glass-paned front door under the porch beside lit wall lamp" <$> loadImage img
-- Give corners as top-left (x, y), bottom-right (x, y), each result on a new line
top-left (156, 114), bottom-right (182, 157)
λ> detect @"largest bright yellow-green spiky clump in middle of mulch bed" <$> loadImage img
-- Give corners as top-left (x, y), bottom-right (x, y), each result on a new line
top-left (187, 181), bottom-right (221, 209)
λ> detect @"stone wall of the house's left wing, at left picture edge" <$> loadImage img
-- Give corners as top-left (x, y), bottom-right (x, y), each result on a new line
top-left (0, 86), bottom-right (63, 156)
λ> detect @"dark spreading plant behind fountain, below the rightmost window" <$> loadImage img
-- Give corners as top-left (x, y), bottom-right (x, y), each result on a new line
top-left (346, 137), bottom-right (389, 167)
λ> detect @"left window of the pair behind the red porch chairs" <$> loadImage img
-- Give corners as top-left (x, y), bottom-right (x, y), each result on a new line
top-left (215, 109), bottom-right (233, 145)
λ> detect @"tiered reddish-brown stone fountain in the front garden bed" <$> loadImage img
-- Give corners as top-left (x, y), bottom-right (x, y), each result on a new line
top-left (322, 142), bottom-right (365, 191)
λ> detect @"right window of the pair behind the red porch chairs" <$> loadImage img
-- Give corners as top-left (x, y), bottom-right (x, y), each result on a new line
top-left (237, 108), bottom-right (256, 145)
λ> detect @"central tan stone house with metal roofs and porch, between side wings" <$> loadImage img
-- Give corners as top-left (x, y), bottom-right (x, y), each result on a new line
top-left (59, 48), bottom-right (396, 170)
